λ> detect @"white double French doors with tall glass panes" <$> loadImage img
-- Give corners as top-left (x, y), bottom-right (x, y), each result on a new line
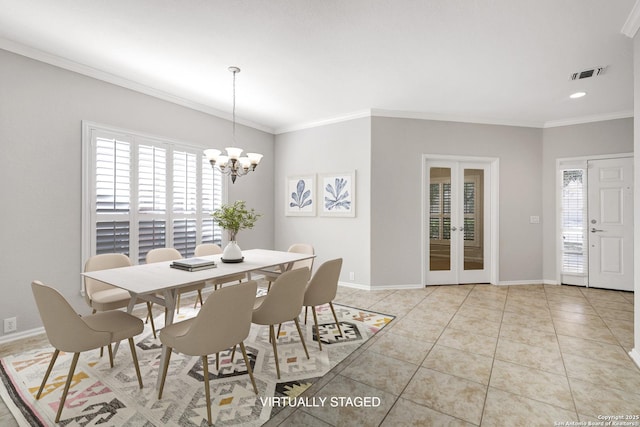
top-left (424, 160), bottom-right (491, 285)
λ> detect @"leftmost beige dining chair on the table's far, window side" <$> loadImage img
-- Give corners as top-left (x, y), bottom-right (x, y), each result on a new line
top-left (84, 254), bottom-right (156, 338)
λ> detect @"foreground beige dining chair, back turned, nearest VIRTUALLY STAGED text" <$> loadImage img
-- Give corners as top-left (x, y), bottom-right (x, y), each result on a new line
top-left (158, 280), bottom-right (258, 425)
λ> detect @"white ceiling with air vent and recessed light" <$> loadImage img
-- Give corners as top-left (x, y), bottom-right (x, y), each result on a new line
top-left (0, 0), bottom-right (634, 133)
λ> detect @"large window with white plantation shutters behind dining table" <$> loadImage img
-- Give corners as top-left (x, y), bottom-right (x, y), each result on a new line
top-left (83, 122), bottom-right (223, 263)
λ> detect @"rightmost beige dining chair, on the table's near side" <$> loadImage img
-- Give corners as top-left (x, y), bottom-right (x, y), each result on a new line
top-left (302, 258), bottom-right (342, 350)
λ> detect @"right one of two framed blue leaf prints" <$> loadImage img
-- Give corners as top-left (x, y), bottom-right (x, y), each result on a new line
top-left (318, 171), bottom-right (356, 217)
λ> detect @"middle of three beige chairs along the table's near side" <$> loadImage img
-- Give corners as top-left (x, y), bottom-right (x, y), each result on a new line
top-left (252, 267), bottom-right (309, 379)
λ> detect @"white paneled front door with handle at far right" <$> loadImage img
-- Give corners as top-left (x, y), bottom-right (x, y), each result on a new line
top-left (587, 157), bottom-right (633, 291)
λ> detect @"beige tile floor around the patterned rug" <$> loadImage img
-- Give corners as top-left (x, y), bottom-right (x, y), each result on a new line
top-left (0, 285), bottom-right (640, 427)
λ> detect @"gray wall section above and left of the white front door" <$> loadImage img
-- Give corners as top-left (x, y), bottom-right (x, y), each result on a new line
top-left (542, 118), bottom-right (633, 282)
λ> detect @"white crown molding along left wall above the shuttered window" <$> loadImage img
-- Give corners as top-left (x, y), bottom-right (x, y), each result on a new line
top-left (0, 37), bottom-right (274, 134)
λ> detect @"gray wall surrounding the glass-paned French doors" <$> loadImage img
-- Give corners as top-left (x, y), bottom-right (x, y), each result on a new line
top-left (371, 117), bottom-right (542, 287)
